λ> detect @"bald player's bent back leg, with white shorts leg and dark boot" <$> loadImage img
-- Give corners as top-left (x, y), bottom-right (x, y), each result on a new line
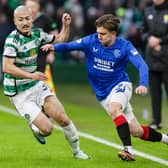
top-left (11, 92), bottom-right (52, 144)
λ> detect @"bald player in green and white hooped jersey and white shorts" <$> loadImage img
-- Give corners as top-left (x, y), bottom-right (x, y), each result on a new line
top-left (3, 6), bottom-right (89, 160)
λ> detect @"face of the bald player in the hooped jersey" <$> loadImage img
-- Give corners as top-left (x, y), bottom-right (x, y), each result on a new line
top-left (14, 10), bottom-right (32, 35)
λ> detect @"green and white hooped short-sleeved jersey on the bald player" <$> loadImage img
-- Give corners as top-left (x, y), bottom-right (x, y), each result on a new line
top-left (3, 29), bottom-right (54, 96)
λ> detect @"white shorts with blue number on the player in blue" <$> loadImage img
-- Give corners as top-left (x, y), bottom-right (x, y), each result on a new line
top-left (100, 82), bottom-right (135, 122)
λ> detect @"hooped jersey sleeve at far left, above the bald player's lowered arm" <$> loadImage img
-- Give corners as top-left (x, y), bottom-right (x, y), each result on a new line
top-left (3, 37), bottom-right (17, 58)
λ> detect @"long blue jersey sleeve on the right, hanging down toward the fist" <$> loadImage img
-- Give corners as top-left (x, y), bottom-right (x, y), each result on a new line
top-left (126, 42), bottom-right (149, 86)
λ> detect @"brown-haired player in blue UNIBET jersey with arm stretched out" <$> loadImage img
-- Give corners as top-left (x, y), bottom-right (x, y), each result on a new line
top-left (42, 14), bottom-right (168, 161)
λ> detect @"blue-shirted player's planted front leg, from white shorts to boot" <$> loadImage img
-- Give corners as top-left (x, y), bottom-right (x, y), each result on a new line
top-left (101, 82), bottom-right (135, 161)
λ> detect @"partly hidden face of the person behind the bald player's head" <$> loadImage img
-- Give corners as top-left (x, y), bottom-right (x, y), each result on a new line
top-left (25, 1), bottom-right (40, 19)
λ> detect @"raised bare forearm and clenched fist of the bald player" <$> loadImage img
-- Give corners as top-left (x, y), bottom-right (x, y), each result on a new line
top-left (53, 13), bottom-right (71, 43)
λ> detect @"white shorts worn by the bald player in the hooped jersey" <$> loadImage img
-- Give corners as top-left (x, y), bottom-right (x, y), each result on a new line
top-left (10, 81), bottom-right (54, 123)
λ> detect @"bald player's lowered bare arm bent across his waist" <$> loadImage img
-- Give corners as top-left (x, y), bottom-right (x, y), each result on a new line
top-left (2, 56), bottom-right (47, 80)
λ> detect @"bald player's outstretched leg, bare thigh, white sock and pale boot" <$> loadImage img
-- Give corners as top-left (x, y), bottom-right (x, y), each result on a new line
top-left (43, 96), bottom-right (89, 159)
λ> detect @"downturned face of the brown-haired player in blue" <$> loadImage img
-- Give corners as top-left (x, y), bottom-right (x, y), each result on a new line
top-left (97, 27), bottom-right (116, 46)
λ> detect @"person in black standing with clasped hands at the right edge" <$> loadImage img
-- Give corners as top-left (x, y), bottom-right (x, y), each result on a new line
top-left (143, 0), bottom-right (168, 129)
